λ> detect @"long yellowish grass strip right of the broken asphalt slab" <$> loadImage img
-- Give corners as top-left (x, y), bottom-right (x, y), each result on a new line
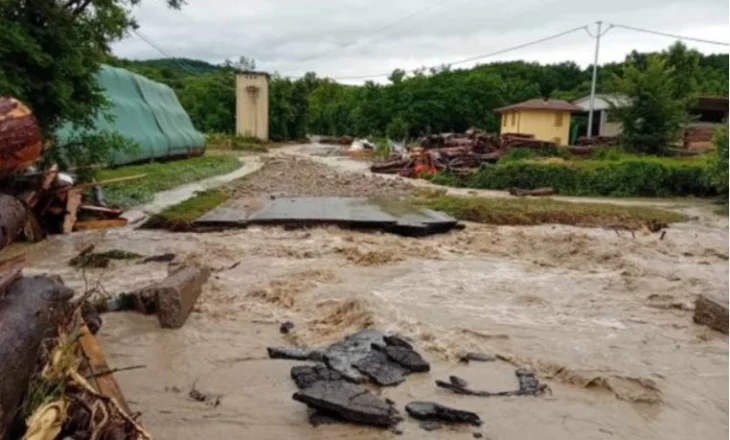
top-left (412, 194), bottom-right (687, 230)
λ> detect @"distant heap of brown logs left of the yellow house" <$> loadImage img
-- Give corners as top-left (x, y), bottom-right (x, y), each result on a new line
top-left (370, 130), bottom-right (555, 177)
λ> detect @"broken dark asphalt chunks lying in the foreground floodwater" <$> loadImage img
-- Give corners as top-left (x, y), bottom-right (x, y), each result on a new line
top-left (267, 329), bottom-right (549, 437)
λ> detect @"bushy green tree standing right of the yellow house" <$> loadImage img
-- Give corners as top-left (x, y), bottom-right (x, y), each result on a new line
top-left (613, 55), bottom-right (687, 154)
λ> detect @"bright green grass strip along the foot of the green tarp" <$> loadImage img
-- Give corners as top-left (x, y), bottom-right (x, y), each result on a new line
top-left (94, 154), bottom-right (241, 208)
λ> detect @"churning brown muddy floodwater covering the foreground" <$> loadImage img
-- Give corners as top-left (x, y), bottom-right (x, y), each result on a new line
top-left (10, 149), bottom-right (728, 440)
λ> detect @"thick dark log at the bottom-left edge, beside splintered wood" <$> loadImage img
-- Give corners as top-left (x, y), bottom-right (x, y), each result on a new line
top-left (0, 276), bottom-right (73, 438)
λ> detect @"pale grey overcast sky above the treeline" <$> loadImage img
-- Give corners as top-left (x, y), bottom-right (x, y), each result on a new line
top-left (113, 0), bottom-right (730, 83)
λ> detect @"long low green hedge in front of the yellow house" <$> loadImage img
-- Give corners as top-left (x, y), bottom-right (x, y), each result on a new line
top-left (432, 157), bottom-right (716, 197)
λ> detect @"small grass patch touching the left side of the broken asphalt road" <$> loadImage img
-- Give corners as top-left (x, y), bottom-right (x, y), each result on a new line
top-left (145, 188), bottom-right (230, 231)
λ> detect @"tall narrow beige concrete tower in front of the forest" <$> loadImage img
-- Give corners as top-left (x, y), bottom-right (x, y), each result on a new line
top-left (236, 72), bottom-right (269, 141)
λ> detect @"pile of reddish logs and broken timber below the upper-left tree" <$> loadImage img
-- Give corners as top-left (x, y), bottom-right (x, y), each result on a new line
top-left (0, 97), bottom-right (135, 253)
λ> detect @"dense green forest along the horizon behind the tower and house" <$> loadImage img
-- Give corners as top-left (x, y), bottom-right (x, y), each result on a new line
top-left (113, 45), bottom-right (728, 140)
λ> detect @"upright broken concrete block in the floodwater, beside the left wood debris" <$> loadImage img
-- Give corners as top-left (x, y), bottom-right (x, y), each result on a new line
top-left (138, 266), bottom-right (210, 328)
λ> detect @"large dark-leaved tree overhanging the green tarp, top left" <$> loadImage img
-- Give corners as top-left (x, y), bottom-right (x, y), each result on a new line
top-left (0, 0), bottom-right (182, 137)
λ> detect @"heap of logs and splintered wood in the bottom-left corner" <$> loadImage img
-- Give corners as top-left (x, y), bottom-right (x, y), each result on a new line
top-left (0, 268), bottom-right (151, 440)
